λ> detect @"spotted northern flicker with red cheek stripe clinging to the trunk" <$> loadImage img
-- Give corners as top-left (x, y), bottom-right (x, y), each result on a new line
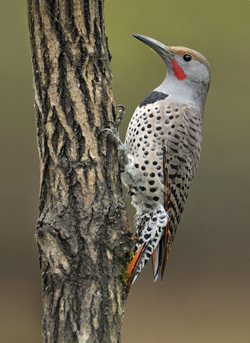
top-left (102, 34), bottom-right (210, 284)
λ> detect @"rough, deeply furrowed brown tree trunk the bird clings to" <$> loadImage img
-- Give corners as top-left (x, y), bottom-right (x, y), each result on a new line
top-left (28, 0), bottom-right (131, 343)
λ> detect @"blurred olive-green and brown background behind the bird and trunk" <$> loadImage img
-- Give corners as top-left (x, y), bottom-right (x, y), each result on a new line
top-left (0, 0), bottom-right (250, 343)
